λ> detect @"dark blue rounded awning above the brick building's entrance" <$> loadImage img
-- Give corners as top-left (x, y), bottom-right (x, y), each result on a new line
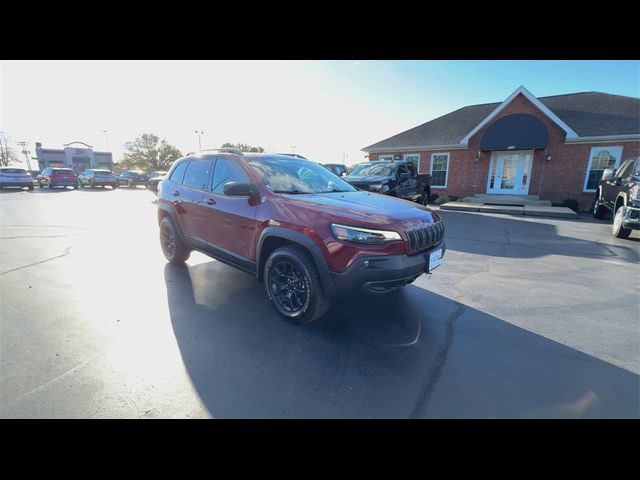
top-left (480, 113), bottom-right (549, 151)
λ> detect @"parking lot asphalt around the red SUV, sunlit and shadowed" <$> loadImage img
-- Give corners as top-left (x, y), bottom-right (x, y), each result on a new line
top-left (0, 188), bottom-right (640, 418)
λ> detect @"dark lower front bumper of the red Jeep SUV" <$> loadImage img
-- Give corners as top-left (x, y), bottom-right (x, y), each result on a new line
top-left (330, 241), bottom-right (447, 297)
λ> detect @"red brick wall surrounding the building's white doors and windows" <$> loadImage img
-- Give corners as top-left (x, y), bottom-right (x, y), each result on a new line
top-left (369, 94), bottom-right (640, 208)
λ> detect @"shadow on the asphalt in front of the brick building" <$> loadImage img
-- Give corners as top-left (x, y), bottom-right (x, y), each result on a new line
top-left (441, 211), bottom-right (640, 262)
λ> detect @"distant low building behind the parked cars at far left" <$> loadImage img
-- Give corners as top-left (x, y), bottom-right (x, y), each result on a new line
top-left (36, 142), bottom-right (113, 173)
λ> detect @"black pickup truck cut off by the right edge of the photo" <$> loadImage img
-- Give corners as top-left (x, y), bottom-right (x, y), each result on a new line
top-left (593, 157), bottom-right (640, 238)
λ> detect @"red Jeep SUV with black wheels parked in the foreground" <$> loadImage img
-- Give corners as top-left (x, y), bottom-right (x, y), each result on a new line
top-left (158, 150), bottom-right (446, 324)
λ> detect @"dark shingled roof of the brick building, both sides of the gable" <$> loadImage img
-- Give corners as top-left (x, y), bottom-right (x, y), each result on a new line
top-left (362, 92), bottom-right (640, 151)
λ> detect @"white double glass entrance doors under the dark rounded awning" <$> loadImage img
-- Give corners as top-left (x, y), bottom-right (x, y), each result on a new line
top-left (487, 151), bottom-right (533, 195)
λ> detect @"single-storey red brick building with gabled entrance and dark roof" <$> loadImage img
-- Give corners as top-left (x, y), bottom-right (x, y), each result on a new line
top-left (362, 87), bottom-right (640, 207)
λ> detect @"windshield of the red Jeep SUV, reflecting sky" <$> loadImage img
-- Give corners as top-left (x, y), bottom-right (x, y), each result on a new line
top-left (248, 157), bottom-right (356, 194)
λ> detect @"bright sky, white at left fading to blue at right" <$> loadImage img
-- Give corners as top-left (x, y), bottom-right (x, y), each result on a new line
top-left (0, 60), bottom-right (640, 164)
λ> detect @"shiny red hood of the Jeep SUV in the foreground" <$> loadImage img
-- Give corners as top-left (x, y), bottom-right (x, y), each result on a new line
top-left (276, 191), bottom-right (440, 229)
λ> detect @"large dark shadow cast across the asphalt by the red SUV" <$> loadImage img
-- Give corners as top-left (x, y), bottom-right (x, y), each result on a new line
top-left (164, 261), bottom-right (639, 418)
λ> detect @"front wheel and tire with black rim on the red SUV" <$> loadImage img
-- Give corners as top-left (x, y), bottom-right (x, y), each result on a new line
top-left (264, 245), bottom-right (329, 325)
